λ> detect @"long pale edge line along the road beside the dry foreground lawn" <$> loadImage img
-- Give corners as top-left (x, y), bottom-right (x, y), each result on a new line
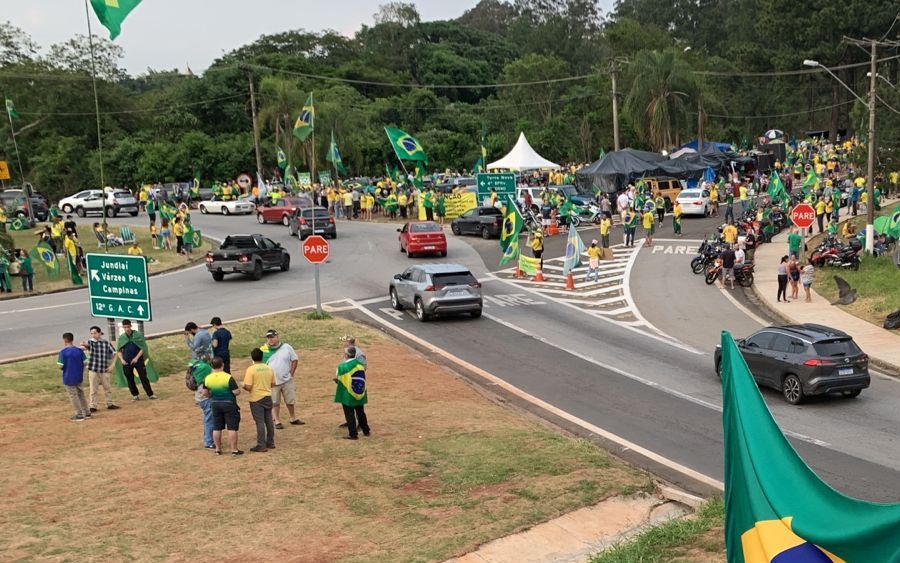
top-left (347, 299), bottom-right (725, 491)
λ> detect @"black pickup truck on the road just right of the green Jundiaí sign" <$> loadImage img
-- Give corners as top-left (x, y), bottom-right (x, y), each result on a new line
top-left (206, 235), bottom-right (291, 281)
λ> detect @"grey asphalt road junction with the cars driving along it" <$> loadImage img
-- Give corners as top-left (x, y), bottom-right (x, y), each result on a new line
top-left (0, 210), bottom-right (900, 501)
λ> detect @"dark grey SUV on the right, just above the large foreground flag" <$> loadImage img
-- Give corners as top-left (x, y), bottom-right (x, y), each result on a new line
top-left (715, 324), bottom-right (870, 405)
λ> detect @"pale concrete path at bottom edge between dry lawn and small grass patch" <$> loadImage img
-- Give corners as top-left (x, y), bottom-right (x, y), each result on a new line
top-left (445, 495), bottom-right (688, 563)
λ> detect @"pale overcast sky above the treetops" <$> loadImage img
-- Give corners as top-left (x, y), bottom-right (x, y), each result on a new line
top-left (8, 0), bottom-right (613, 75)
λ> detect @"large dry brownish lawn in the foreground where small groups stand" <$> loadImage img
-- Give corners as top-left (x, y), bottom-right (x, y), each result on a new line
top-left (0, 313), bottom-right (653, 562)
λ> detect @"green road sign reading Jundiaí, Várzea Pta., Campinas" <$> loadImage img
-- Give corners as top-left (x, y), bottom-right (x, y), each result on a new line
top-left (86, 254), bottom-right (152, 321)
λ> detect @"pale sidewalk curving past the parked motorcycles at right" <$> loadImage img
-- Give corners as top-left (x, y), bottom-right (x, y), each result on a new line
top-left (753, 201), bottom-right (900, 372)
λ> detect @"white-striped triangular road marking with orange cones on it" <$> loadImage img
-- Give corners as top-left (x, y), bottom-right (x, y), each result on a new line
top-left (494, 243), bottom-right (656, 332)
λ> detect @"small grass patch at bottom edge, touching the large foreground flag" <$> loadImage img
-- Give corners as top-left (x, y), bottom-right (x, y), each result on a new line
top-left (590, 497), bottom-right (725, 563)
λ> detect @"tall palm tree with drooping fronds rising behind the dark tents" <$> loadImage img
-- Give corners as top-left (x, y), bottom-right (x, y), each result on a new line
top-left (624, 50), bottom-right (698, 150)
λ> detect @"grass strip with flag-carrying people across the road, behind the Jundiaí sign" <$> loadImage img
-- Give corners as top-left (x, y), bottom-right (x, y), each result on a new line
top-left (0, 224), bottom-right (211, 299)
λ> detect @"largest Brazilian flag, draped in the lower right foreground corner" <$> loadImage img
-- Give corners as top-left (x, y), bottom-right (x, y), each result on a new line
top-left (721, 332), bottom-right (900, 563)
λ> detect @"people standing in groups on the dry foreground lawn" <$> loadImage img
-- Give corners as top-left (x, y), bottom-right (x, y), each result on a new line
top-left (57, 317), bottom-right (371, 456)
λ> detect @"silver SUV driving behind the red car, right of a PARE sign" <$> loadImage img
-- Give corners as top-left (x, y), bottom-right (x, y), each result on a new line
top-left (390, 264), bottom-right (482, 322)
